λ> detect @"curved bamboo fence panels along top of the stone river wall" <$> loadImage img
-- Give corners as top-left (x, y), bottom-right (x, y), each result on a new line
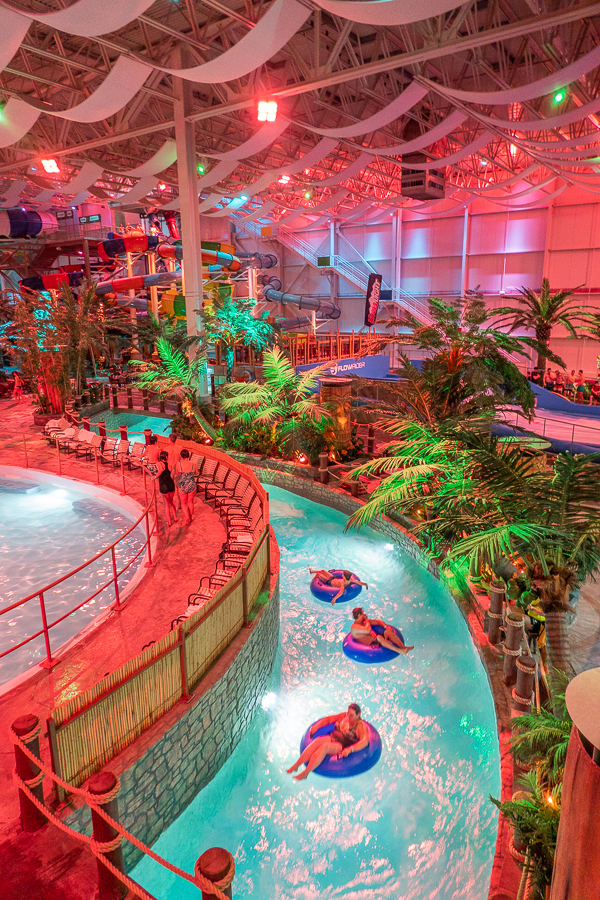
top-left (48, 435), bottom-right (271, 785)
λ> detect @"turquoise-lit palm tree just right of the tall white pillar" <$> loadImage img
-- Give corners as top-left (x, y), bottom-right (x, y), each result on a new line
top-left (204, 289), bottom-right (275, 382)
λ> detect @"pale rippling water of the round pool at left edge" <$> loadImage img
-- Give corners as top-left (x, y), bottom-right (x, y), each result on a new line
top-left (0, 476), bottom-right (145, 684)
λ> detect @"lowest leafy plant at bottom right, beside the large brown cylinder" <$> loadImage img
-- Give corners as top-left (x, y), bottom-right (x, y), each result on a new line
top-left (490, 772), bottom-right (560, 900)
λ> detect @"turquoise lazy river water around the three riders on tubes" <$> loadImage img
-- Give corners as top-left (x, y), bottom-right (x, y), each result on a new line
top-left (133, 487), bottom-right (500, 900)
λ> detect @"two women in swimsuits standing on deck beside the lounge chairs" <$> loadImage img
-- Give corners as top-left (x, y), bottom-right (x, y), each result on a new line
top-left (144, 433), bottom-right (197, 525)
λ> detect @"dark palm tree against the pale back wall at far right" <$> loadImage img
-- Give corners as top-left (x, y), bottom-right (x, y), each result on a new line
top-left (495, 278), bottom-right (593, 369)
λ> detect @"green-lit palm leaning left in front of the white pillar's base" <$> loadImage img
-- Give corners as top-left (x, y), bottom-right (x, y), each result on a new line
top-left (129, 337), bottom-right (215, 438)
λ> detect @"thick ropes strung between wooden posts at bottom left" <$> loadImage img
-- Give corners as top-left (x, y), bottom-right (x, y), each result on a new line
top-left (9, 725), bottom-right (235, 900)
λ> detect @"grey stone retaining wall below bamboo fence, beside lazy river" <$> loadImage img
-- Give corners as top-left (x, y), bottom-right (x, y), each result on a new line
top-left (67, 581), bottom-right (279, 869)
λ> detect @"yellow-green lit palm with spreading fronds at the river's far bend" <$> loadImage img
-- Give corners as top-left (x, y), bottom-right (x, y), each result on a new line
top-left (219, 347), bottom-right (331, 456)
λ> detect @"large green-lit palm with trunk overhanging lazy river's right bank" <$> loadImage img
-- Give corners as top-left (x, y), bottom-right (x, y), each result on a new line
top-left (349, 422), bottom-right (600, 673)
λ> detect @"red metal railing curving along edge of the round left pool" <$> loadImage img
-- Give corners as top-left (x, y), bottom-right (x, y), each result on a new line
top-left (0, 484), bottom-right (158, 669)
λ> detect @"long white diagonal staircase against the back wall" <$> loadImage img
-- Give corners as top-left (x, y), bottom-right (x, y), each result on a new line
top-left (236, 219), bottom-right (431, 325)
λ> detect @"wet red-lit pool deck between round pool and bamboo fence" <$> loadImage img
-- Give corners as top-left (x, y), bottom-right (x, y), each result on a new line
top-left (0, 401), bottom-right (225, 900)
